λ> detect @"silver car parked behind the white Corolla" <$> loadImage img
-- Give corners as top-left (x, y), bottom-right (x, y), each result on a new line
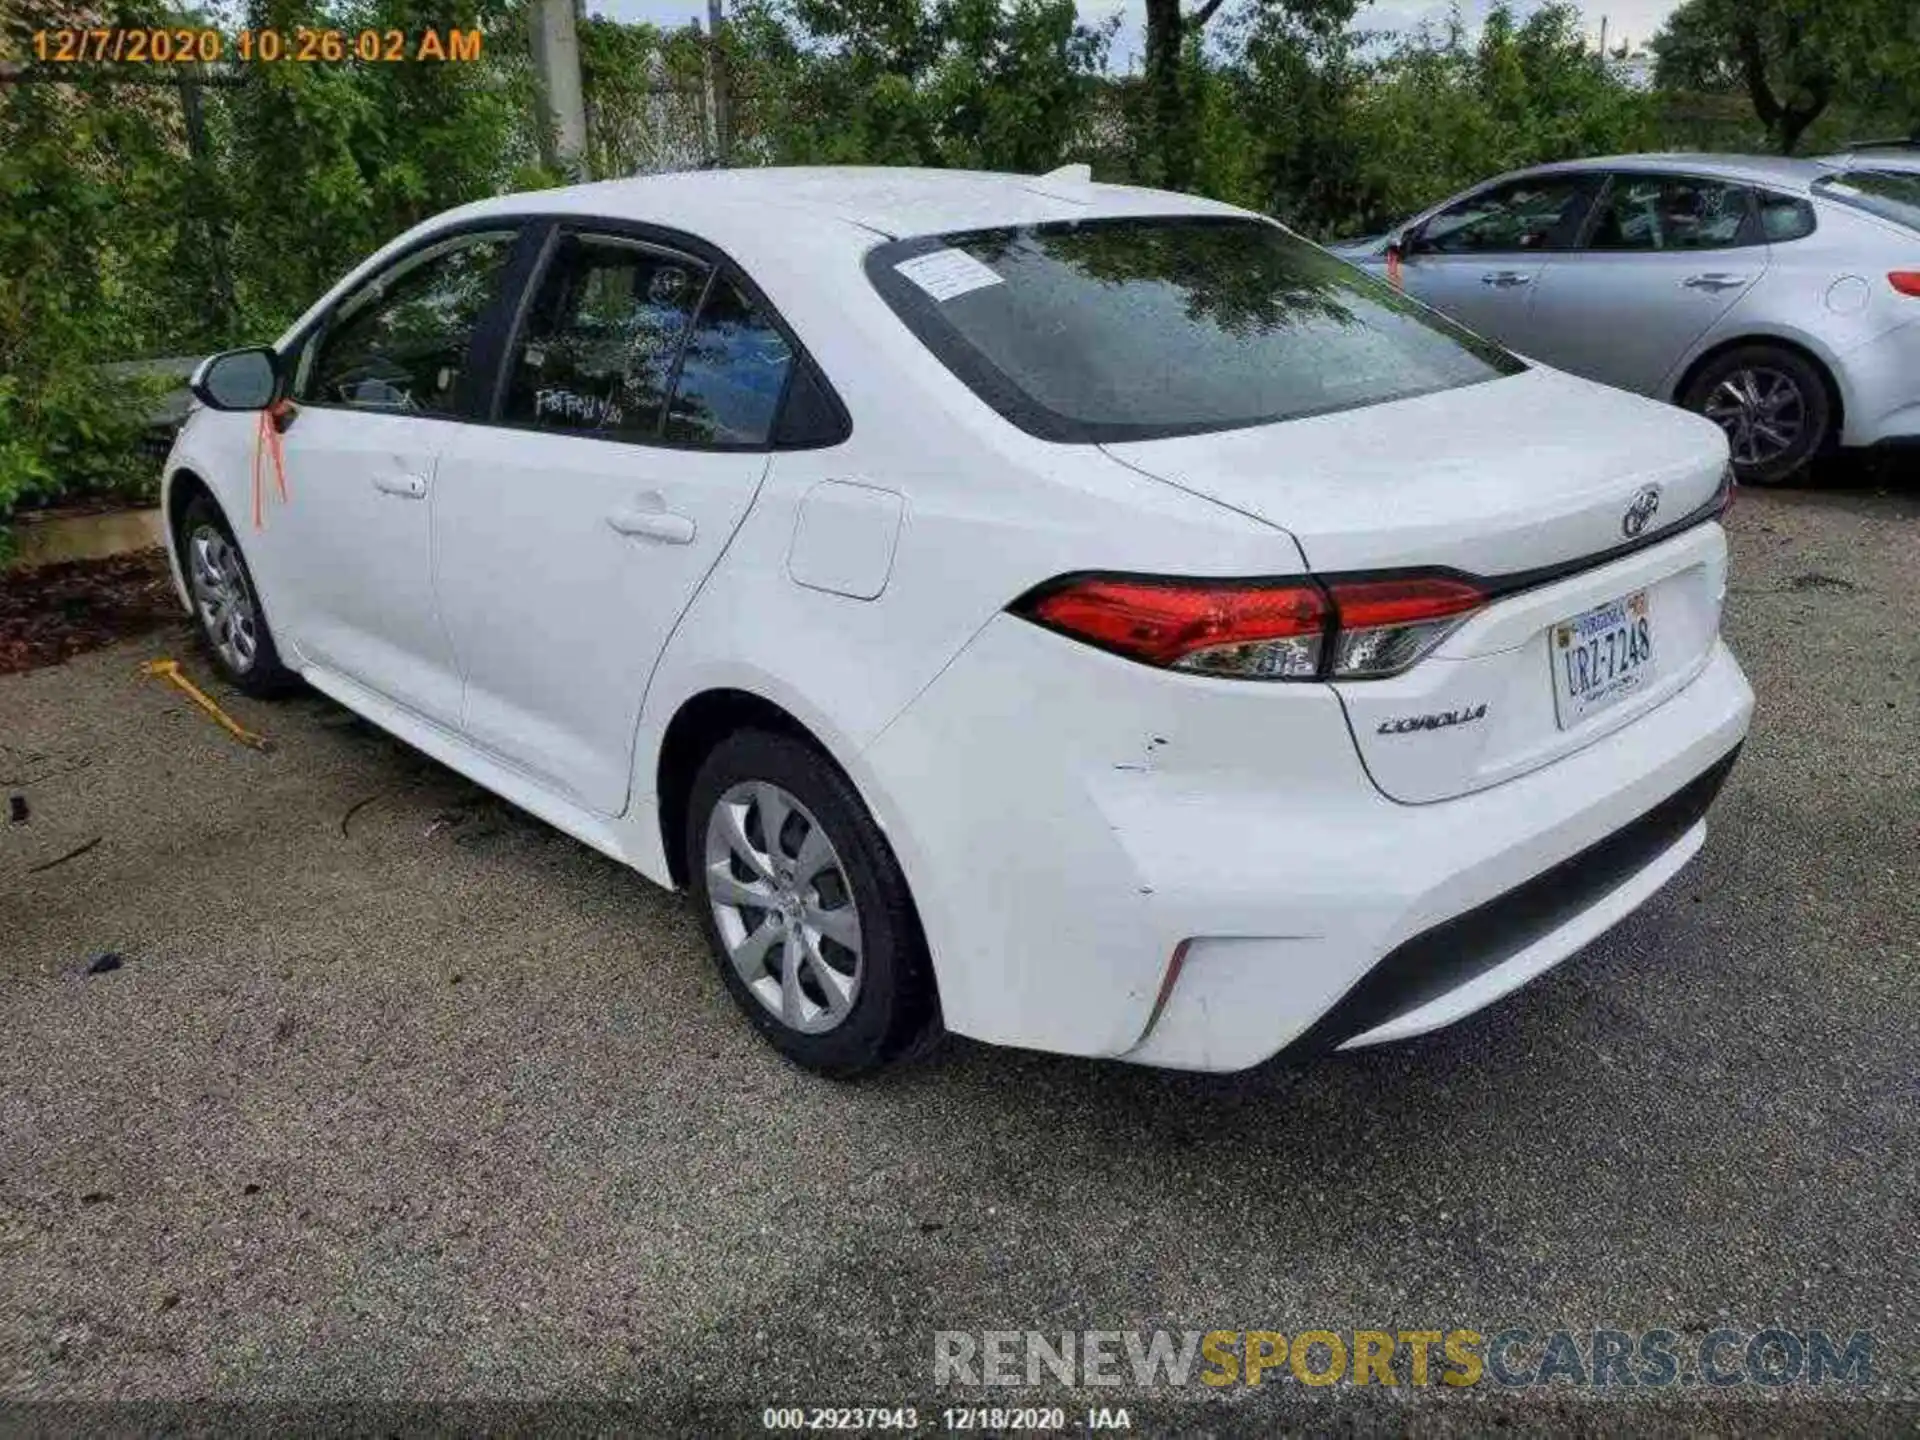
top-left (1332, 156), bottom-right (1920, 484)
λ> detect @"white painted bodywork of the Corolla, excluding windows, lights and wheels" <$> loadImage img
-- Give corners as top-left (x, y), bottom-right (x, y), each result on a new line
top-left (167, 171), bottom-right (1753, 1069)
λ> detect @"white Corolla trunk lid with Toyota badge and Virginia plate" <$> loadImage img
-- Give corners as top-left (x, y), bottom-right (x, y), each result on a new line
top-left (1106, 369), bottom-right (1726, 803)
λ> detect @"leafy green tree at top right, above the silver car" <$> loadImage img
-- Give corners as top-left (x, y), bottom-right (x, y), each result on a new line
top-left (1653, 0), bottom-right (1920, 156)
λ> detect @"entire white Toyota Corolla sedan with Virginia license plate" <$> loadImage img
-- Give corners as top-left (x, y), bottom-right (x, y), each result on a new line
top-left (165, 169), bottom-right (1753, 1073)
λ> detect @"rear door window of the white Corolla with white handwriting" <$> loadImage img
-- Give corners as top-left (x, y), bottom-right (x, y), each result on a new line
top-left (501, 234), bottom-right (710, 440)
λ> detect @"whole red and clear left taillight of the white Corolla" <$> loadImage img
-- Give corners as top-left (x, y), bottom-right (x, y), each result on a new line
top-left (1014, 574), bottom-right (1486, 680)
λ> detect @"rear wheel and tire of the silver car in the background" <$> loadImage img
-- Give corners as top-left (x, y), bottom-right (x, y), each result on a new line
top-left (1680, 346), bottom-right (1834, 486)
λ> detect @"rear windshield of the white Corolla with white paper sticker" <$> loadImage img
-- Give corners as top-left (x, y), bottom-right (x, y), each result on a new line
top-left (866, 217), bottom-right (1526, 442)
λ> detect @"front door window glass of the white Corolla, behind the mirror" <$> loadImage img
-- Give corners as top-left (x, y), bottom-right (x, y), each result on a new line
top-left (294, 232), bottom-right (515, 415)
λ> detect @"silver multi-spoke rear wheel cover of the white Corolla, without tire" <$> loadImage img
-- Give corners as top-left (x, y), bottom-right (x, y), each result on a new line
top-left (707, 780), bottom-right (864, 1035)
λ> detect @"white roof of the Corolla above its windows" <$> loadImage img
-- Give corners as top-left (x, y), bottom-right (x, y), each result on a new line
top-left (442, 165), bottom-right (1244, 248)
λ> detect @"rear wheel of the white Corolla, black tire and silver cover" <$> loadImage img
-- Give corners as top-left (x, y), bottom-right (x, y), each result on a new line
top-left (684, 730), bottom-right (937, 1079)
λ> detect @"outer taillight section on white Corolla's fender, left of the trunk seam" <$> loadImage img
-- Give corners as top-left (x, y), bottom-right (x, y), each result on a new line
top-left (1020, 576), bottom-right (1327, 680)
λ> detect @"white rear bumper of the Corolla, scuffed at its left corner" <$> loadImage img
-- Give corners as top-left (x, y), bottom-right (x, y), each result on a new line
top-left (852, 616), bottom-right (1753, 1071)
